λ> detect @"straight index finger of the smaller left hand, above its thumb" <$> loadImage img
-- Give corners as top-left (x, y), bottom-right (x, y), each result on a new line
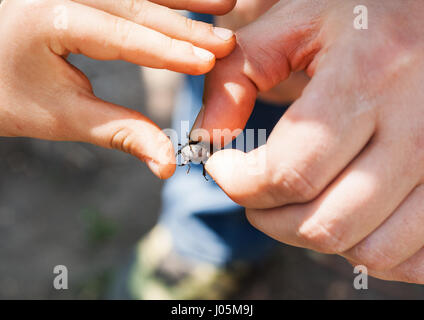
top-left (52, 1), bottom-right (215, 75)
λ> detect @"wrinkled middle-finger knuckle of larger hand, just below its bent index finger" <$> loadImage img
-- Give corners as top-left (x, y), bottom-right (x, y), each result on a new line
top-left (296, 220), bottom-right (349, 254)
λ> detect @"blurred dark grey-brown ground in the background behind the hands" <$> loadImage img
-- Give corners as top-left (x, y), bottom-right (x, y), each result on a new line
top-left (0, 56), bottom-right (424, 299)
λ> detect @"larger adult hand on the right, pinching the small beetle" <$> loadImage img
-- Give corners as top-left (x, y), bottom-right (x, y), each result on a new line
top-left (195, 0), bottom-right (424, 284)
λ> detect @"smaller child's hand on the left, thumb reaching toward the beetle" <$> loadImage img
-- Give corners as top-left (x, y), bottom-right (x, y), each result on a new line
top-left (0, 0), bottom-right (235, 178)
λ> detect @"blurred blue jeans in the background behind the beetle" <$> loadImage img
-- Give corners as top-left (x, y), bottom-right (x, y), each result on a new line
top-left (160, 14), bottom-right (287, 265)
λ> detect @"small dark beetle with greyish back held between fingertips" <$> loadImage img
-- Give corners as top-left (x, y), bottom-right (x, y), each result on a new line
top-left (176, 140), bottom-right (211, 181)
